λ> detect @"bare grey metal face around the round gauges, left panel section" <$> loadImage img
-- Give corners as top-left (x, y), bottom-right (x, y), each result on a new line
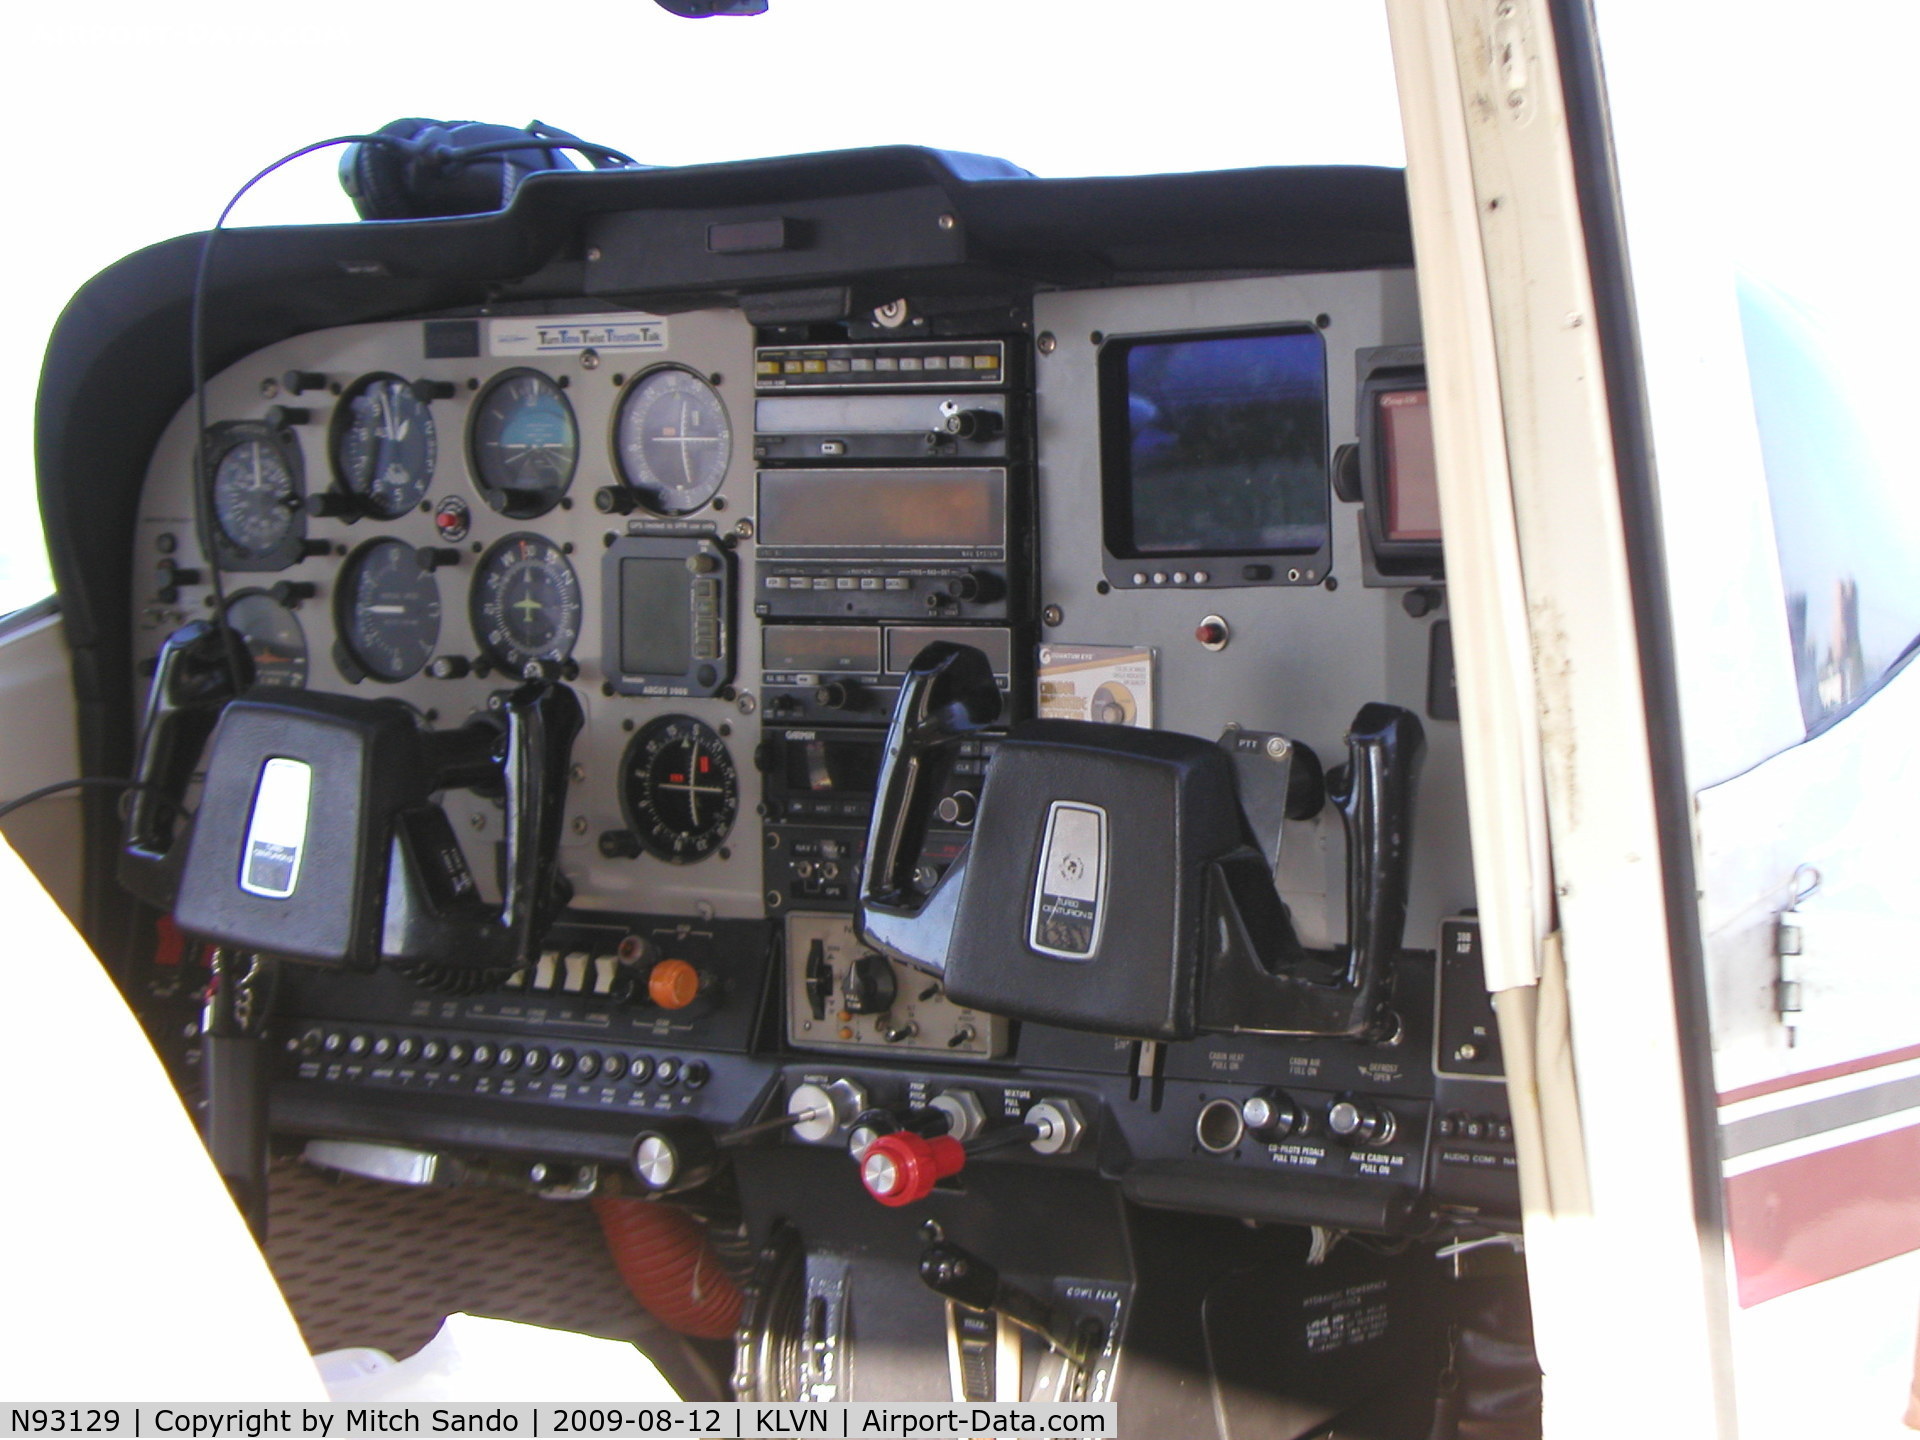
top-left (132, 311), bottom-right (764, 918)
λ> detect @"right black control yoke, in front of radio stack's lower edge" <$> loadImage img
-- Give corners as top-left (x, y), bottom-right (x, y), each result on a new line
top-left (858, 645), bottom-right (1425, 1039)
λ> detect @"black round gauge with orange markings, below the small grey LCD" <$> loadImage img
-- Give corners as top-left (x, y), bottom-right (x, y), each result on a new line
top-left (620, 714), bottom-right (739, 864)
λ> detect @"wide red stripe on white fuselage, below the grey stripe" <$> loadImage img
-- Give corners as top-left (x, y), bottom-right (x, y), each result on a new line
top-left (1726, 1125), bottom-right (1920, 1308)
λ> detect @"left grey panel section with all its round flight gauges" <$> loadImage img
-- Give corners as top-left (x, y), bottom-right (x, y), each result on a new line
top-left (134, 311), bottom-right (764, 918)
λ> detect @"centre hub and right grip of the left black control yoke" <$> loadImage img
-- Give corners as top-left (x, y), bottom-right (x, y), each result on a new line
top-left (175, 684), bottom-right (582, 970)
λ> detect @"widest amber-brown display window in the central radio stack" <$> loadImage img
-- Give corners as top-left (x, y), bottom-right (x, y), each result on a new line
top-left (760, 470), bottom-right (1006, 553)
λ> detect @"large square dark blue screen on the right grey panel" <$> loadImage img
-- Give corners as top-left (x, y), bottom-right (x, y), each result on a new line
top-left (1100, 330), bottom-right (1329, 557)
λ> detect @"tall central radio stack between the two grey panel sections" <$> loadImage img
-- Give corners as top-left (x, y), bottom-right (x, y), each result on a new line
top-left (753, 340), bottom-right (1033, 1060)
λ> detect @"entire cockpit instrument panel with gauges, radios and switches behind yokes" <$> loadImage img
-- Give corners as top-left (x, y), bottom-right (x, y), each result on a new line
top-left (134, 271), bottom-right (1511, 1229)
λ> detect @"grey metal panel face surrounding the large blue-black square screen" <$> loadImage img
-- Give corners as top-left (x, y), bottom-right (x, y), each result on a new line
top-left (1033, 271), bottom-right (1473, 948)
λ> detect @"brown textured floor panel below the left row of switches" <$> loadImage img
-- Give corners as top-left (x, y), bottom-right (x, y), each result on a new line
top-left (267, 1160), bottom-right (726, 1400)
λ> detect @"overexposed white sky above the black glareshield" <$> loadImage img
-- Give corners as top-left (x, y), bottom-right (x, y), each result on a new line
top-left (0, 0), bottom-right (1404, 612)
